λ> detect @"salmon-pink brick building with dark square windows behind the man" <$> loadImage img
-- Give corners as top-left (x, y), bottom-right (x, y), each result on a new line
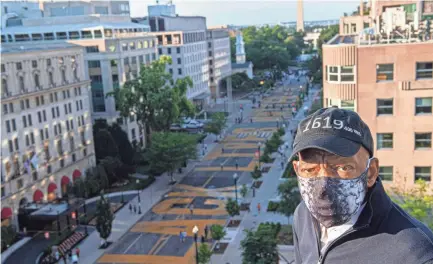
top-left (323, 1), bottom-right (433, 189)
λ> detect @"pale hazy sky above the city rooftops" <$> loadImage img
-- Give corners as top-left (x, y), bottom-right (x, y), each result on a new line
top-left (130, 0), bottom-right (360, 26)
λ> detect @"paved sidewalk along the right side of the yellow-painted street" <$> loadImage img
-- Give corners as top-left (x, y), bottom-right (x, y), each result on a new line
top-left (211, 85), bottom-right (318, 264)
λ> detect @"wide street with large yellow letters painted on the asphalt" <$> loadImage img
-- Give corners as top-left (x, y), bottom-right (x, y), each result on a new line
top-left (97, 81), bottom-right (302, 264)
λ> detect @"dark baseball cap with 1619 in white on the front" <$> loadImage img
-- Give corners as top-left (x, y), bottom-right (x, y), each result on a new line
top-left (290, 107), bottom-right (374, 159)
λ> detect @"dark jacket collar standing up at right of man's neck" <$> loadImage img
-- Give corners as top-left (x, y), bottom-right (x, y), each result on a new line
top-left (354, 178), bottom-right (392, 228)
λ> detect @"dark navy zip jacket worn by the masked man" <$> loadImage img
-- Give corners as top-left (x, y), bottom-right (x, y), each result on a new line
top-left (293, 180), bottom-right (433, 264)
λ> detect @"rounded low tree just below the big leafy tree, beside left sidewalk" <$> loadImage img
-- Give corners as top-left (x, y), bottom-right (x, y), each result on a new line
top-left (148, 132), bottom-right (197, 182)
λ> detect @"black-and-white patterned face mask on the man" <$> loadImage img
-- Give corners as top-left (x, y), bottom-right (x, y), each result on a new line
top-left (298, 159), bottom-right (371, 228)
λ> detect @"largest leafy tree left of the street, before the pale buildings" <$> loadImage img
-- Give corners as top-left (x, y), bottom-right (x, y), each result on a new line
top-left (107, 56), bottom-right (194, 146)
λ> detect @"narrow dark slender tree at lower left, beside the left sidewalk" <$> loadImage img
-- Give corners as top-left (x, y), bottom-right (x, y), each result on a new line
top-left (96, 194), bottom-right (114, 242)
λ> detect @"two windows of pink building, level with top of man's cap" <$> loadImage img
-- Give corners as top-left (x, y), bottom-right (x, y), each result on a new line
top-left (376, 97), bottom-right (433, 116)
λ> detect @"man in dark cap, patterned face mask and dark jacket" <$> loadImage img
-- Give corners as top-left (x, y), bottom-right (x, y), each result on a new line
top-left (292, 108), bottom-right (433, 264)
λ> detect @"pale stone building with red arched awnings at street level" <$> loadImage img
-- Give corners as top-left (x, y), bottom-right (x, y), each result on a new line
top-left (1, 44), bottom-right (95, 227)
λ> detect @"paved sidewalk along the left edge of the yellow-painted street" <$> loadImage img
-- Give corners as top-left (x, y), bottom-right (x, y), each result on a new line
top-left (59, 105), bottom-right (248, 264)
